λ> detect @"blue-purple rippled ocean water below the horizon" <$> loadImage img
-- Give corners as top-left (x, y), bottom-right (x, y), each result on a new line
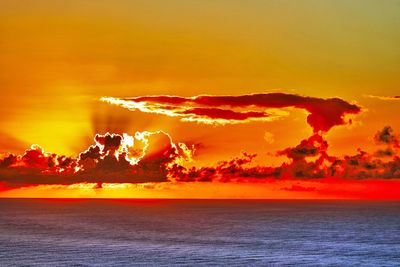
top-left (0, 199), bottom-right (400, 266)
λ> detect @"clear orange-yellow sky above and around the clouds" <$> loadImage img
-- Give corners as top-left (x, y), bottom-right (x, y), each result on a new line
top-left (0, 0), bottom-right (400, 200)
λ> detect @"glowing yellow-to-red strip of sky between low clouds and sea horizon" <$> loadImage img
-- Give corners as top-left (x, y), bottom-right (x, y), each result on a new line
top-left (0, 179), bottom-right (400, 199)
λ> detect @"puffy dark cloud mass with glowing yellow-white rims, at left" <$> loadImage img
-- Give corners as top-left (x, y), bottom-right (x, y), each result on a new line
top-left (0, 131), bottom-right (194, 185)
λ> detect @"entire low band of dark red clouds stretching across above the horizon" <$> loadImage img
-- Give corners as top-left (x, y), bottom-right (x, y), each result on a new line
top-left (0, 127), bottom-right (400, 186)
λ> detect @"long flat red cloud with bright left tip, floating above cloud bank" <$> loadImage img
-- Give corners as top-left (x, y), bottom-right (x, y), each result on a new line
top-left (101, 93), bottom-right (361, 133)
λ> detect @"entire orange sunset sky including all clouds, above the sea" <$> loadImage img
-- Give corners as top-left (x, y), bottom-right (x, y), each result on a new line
top-left (0, 0), bottom-right (400, 198)
